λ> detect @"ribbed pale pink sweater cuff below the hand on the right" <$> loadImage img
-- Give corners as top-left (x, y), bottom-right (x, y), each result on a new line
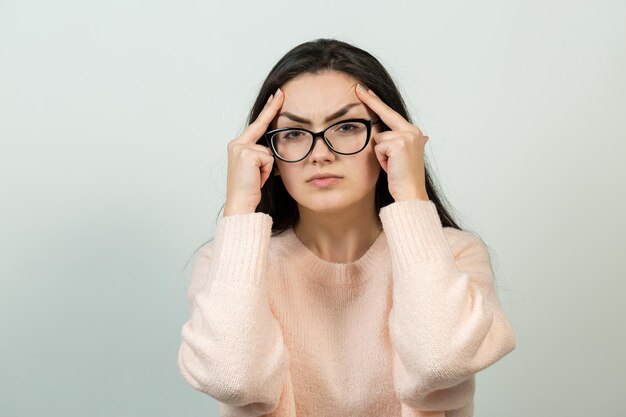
top-left (379, 199), bottom-right (454, 268)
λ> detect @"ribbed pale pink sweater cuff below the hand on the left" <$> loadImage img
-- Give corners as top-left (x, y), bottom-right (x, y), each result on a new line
top-left (211, 213), bottom-right (272, 284)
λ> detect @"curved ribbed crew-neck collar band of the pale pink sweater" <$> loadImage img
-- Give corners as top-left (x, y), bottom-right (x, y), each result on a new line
top-left (282, 228), bottom-right (387, 287)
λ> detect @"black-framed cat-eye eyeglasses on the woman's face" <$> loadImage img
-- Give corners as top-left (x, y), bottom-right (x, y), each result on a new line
top-left (265, 119), bottom-right (380, 162)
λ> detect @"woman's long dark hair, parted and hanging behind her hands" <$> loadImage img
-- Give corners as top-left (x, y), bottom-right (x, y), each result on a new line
top-left (180, 38), bottom-right (472, 270)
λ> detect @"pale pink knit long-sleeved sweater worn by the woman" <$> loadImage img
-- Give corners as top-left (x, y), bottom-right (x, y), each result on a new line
top-left (178, 200), bottom-right (516, 417)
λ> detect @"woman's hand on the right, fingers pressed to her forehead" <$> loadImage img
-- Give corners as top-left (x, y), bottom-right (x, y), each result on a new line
top-left (355, 83), bottom-right (429, 201)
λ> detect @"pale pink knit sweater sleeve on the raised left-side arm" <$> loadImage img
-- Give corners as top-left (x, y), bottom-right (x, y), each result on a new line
top-left (178, 213), bottom-right (290, 417)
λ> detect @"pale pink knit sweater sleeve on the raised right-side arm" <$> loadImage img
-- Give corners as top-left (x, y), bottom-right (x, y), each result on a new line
top-left (380, 200), bottom-right (516, 411)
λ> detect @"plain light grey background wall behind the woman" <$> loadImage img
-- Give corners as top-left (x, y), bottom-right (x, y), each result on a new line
top-left (0, 0), bottom-right (626, 417)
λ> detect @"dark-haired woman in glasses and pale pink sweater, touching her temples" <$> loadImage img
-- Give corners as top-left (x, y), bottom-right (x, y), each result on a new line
top-left (178, 39), bottom-right (515, 417)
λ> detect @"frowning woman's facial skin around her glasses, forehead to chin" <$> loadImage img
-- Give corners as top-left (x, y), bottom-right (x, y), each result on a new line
top-left (270, 71), bottom-right (381, 212)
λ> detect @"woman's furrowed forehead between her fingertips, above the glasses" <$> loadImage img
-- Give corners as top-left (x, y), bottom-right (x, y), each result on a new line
top-left (272, 71), bottom-right (366, 126)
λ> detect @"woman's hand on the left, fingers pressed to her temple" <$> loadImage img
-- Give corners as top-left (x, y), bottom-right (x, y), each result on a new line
top-left (224, 89), bottom-right (284, 216)
